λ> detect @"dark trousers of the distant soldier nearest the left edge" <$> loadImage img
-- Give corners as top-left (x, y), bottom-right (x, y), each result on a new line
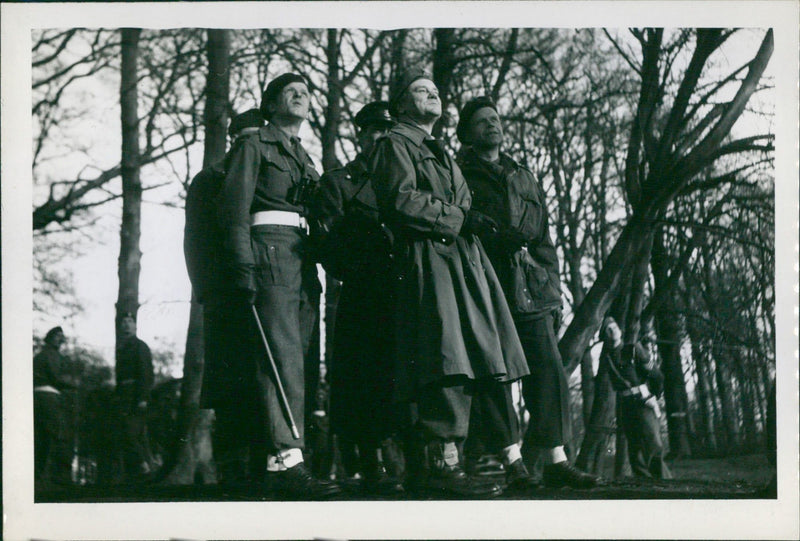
top-left (33, 391), bottom-right (72, 480)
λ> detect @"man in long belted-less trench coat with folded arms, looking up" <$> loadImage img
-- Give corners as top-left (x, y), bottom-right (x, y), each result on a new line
top-left (371, 70), bottom-right (528, 498)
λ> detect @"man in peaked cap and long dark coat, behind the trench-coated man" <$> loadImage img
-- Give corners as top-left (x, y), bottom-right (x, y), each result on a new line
top-left (312, 101), bottom-right (398, 493)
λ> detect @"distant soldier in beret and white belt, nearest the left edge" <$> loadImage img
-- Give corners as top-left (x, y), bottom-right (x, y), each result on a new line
top-left (33, 327), bottom-right (72, 483)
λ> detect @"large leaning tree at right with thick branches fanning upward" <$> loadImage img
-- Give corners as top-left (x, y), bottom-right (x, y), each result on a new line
top-left (559, 29), bottom-right (774, 376)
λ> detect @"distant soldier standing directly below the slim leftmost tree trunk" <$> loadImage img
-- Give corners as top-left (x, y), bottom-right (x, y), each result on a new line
top-left (115, 312), bottom-right (153, 477)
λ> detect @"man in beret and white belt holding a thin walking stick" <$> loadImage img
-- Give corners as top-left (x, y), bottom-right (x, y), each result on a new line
top-left (207, 73), bottom-right (339, 500)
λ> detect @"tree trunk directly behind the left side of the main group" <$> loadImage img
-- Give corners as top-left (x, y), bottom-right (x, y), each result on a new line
top-left (166, 29), bottom-right (230, 485)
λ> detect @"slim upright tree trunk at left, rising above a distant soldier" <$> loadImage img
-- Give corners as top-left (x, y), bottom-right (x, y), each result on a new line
top-left (115, 28), bottom-right (142, 334)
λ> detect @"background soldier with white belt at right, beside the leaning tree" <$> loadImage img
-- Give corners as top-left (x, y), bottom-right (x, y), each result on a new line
top-left (600, 317), bottom-right (672, 479)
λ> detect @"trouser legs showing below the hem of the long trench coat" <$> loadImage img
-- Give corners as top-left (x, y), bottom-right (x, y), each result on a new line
top-left (416, 378), bottom-right (519, 452)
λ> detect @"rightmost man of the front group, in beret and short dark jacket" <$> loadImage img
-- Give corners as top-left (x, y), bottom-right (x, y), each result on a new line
top-left (456, 97), bottom-right (598, 488)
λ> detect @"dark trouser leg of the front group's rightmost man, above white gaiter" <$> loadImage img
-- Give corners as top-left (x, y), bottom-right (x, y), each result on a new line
top-left (515, 313), bottom-right (569, 449)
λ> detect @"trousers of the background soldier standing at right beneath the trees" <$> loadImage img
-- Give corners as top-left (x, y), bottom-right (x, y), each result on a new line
top-left (617, 394), bottom-right (672, 479)
